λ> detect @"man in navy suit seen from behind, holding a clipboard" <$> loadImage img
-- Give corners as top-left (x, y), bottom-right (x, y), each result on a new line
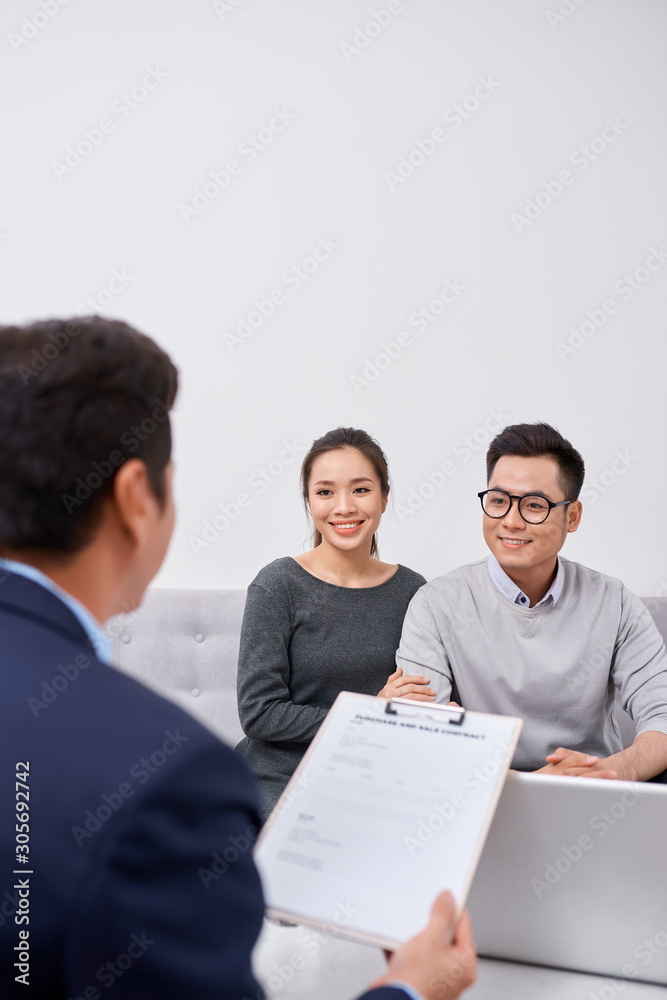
top-left (0, 318), bottom-right (475, 1000)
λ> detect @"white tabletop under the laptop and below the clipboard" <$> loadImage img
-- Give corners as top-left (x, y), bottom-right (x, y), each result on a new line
top-left (254, 922), bottom-right (665, 1000)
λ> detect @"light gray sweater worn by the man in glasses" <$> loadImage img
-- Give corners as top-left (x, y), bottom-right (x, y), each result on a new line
top-left (396, 557), bottom-right (667, 771)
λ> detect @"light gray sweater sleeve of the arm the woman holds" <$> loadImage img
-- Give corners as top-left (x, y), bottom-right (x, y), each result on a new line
top-left (396, 588), bottom-right (452, 703)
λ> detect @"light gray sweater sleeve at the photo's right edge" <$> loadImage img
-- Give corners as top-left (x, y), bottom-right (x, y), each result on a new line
top-left (612, 587), bottom-right (667, 735)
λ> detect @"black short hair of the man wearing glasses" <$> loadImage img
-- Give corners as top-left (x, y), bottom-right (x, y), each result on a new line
top-left (486, 423), bottom-right (586, 500)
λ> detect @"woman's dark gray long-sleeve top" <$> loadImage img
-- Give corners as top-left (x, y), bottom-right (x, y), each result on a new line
top-left (237, 557), bottom-right (426, 812)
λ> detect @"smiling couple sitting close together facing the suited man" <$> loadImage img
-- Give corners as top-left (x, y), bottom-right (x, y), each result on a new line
top-left (237, 424), bottom-right (667, 816)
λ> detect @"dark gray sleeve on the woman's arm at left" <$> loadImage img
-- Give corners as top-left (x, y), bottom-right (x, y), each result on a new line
top-left (237, 583), bottom-right (327, 743)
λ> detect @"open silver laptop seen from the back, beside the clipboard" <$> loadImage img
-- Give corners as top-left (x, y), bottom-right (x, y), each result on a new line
top-left (467, 773), bottom-right (667, 985)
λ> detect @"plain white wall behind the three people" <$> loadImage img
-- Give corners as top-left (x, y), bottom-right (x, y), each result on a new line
top-left (0, 0), bottom-right (667, 594)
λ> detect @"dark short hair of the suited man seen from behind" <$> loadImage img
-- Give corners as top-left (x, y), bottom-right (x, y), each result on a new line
top-left (0, 316), bottom-right (178, 554)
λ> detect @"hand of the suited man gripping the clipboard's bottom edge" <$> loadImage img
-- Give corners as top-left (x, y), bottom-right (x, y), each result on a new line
top-left (369, 892), bottom-right (477, 1000)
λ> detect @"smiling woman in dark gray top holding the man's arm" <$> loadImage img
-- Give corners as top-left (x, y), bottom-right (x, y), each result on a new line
top-left (237, 427), bottom-right (434, 818)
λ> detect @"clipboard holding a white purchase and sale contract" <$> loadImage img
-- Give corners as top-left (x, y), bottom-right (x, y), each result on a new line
top-left (255, 691), bottom-right (523, 950)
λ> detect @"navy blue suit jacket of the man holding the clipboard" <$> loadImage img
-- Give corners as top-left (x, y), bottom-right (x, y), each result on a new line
top-left (0, 574), bottom-right (405, 1000)
